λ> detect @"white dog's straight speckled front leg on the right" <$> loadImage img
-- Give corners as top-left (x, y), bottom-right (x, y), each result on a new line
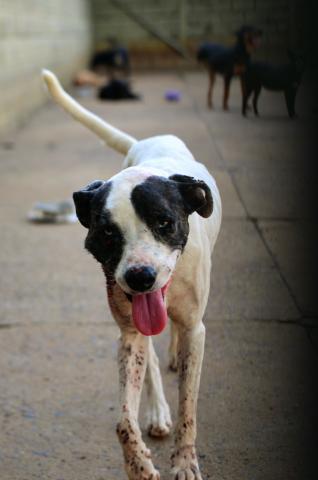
top-left (171, 323), bottom-right (205, 480)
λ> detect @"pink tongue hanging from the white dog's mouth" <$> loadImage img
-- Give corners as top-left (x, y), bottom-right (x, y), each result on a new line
top-left (132, 290), bottom-right (168, 336)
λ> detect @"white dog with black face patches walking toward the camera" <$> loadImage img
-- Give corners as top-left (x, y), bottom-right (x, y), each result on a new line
top-left (43, 70), bottom-right (221, 480)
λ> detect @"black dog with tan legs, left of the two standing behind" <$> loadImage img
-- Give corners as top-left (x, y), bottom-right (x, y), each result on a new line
top-left (197, 25), bottom-right (262, 110)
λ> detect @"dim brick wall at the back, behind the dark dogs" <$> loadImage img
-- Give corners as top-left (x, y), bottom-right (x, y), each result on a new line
top-left (92, 0), bottom-right (301, 66)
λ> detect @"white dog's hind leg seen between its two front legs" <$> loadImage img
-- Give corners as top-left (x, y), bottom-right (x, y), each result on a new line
top-left (146, 337), bottom-right (172, 437)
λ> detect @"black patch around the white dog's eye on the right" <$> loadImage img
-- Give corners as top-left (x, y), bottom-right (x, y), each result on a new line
top-left (131, 176), bottom-right (189, 250)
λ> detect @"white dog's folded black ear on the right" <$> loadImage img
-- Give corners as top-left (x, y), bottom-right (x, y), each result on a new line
top-left (169, 174), bottom-right (213, 218)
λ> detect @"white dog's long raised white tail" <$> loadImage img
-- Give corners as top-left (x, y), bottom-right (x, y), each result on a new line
top-left (42, 70), bottom-right (137, 155)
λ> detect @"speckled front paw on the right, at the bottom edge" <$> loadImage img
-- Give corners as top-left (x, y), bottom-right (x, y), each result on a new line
top-left (171, 445), bottom-right (202, 480)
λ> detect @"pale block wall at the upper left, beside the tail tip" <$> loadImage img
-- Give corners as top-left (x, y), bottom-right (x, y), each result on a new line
top-left (0, 0), bottom-right (91, 134)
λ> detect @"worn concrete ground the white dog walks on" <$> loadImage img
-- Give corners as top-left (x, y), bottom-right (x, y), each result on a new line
top-left (0, 73), bottom-right (318, 480)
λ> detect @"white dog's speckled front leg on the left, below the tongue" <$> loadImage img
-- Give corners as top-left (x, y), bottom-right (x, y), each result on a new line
top-left (117, 331), bottom-right (160, 480)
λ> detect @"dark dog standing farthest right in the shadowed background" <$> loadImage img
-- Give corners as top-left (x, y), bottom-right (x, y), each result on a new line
top-left (242, 52), bottom-right (305, 118)
